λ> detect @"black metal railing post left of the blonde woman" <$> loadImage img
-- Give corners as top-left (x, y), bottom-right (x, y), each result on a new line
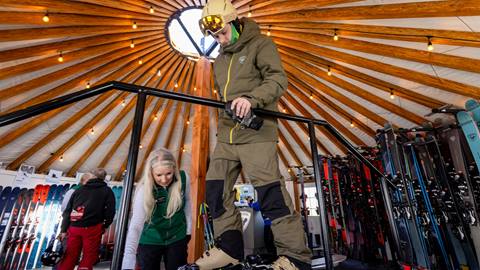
top-left (110, 90), bottom-right (146, 270)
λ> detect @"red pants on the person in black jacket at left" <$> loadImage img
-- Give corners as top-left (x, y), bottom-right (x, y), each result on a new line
top-left (57, 224), bottom-right (103, 270)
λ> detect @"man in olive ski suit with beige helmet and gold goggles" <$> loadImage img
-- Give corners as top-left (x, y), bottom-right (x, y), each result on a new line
top-left (195, 0), bottom-right (311, 270)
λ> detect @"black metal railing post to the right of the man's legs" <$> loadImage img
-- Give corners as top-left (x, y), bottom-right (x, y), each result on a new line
top-left (308, 122), bottom-right (333, 270)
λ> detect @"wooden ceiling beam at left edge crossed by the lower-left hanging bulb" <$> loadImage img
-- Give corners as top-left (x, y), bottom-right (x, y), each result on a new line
top-left (0, 36), bottom-right (163, 80)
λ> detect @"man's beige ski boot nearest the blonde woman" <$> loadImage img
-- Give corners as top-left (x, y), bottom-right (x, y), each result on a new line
top-left (178, 247), bottom-right (243, 270)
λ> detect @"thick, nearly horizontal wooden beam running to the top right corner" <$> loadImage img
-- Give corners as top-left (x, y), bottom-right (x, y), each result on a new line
top-left (255, 0), bottom-right (480, 23)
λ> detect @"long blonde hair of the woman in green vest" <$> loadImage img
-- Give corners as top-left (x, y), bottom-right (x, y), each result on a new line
top-left (141, 148), bottom-right (183, 222)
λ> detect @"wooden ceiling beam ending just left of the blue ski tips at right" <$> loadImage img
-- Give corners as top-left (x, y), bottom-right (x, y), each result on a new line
top-left (279, 46), bottom-right (445, 108)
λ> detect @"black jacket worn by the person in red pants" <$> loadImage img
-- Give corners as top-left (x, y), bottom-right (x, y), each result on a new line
top-left (62, 179), bottom-right (115, 233)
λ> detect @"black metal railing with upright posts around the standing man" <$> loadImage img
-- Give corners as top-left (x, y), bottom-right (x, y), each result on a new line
top-left (0, 81), bottom-right (400, 270)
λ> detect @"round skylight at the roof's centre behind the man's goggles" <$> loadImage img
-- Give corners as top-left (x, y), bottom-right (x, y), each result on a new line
top-left (168, 8), bottom-right (219, 58)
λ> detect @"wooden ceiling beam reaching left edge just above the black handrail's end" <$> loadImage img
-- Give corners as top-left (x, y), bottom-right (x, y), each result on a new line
top-left (0, 42), bottom-right (165, 106)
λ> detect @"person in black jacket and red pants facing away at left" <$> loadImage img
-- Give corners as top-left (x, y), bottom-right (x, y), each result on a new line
top-left (57, 169), bottom-right (115, 270)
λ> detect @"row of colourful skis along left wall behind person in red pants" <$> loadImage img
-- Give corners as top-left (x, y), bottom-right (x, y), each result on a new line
top-left (0, 170), bottom-right (122, 270)
